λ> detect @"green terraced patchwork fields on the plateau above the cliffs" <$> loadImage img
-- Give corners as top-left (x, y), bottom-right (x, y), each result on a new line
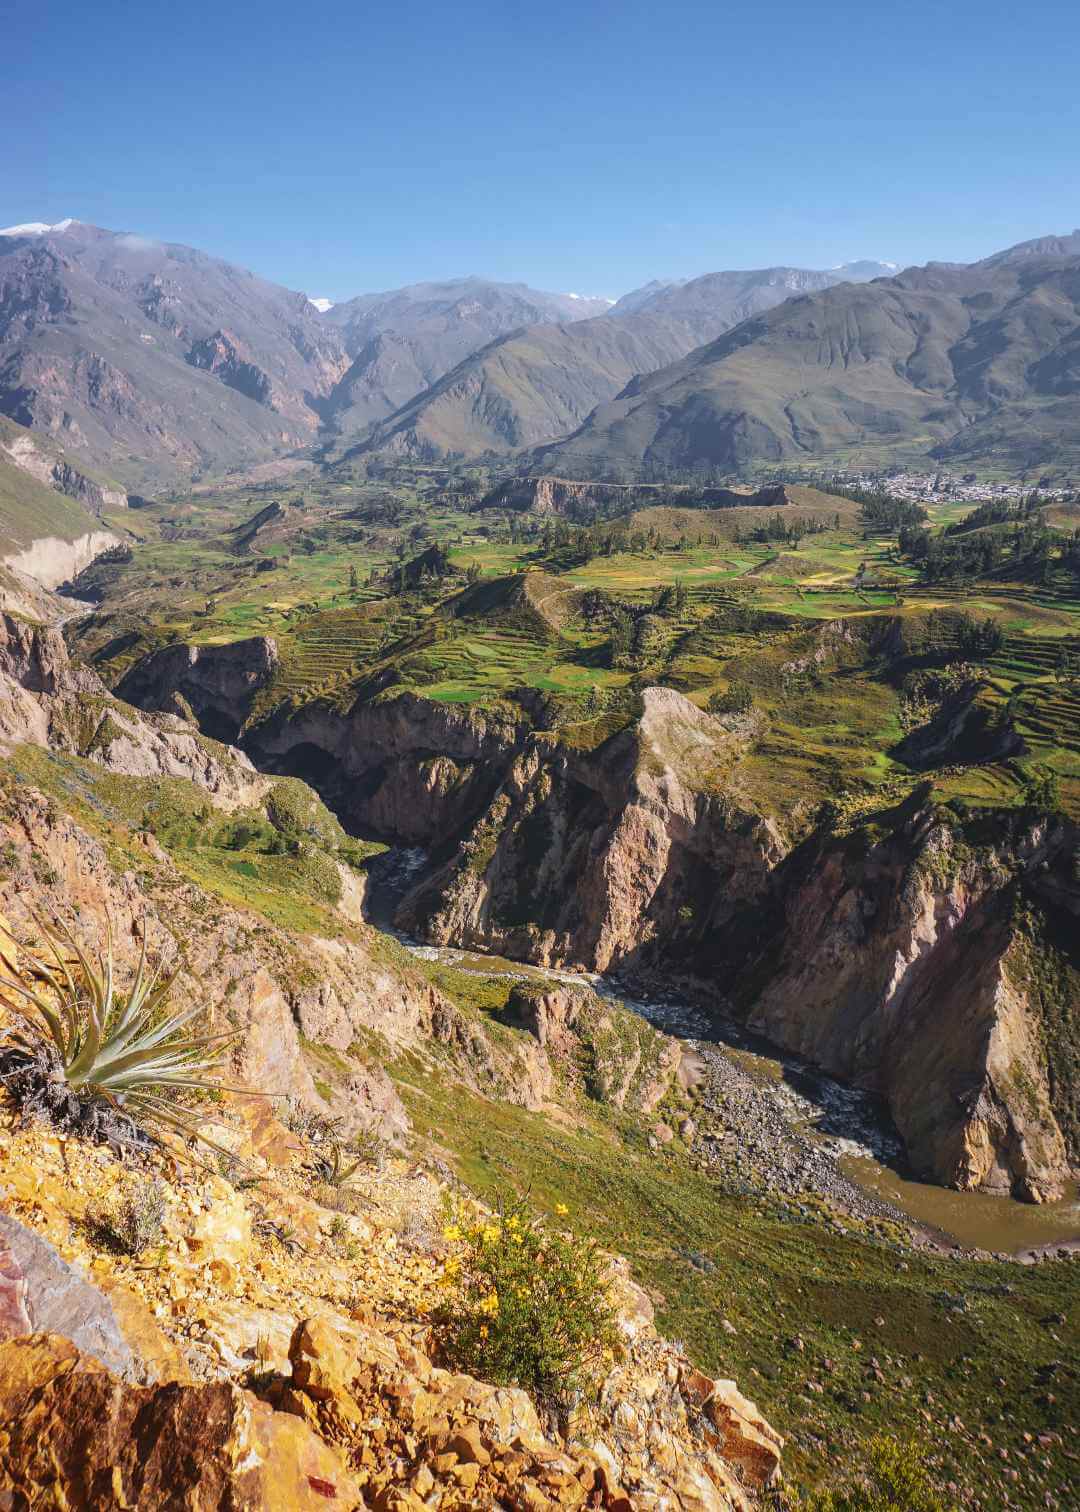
top-left (58, 469), bottom-right (1080, 820)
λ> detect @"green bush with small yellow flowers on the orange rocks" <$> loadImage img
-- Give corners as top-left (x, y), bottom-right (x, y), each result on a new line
top-left (436, 1199), bottom-right (614, 1399)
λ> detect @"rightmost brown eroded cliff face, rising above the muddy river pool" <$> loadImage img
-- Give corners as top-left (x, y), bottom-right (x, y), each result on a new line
top-left (707, 803), bottom-right (1080, 1201)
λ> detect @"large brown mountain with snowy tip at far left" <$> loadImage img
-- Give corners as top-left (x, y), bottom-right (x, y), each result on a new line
top-left (0, 221), bottom-right (348, 487)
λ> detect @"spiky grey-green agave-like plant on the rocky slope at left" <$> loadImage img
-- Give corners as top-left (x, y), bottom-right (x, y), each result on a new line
top-left (0, 919), bottom-right (236, 1146)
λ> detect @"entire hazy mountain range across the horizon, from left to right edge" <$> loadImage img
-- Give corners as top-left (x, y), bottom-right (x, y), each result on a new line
top-left (0, 221), bottom-right (1080, 488)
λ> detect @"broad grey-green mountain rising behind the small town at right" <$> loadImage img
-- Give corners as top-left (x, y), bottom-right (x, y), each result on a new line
top-left (526, 233), bottom-right (1080, 478)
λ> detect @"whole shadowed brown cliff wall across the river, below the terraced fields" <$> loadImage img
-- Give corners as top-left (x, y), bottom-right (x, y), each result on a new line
top-left (240, 688), bottom-right (1080, 1201)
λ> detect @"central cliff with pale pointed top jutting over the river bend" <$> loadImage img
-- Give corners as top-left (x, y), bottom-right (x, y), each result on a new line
top-left (399, 688), bottom-right (782, 971)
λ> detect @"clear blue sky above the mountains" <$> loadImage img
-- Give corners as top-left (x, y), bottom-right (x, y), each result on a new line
top-left (10, 0), bottom-right (1080, 299)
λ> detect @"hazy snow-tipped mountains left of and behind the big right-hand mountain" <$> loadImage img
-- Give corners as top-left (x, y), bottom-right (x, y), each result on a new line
top-left (0, 219), bottom-right (883, 488)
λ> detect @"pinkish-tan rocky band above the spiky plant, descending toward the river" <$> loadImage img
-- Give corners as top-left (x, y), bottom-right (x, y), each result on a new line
top-left (0, 785), bottom-right (647, 1143)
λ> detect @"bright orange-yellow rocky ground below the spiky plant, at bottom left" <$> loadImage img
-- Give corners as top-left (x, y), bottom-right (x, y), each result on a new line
top-left (0, 959), bottom-right (781, 1512)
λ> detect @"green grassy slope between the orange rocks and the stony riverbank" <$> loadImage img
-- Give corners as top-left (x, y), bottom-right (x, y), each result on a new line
top-left (393, 1046), bottom-right (1080, 1509)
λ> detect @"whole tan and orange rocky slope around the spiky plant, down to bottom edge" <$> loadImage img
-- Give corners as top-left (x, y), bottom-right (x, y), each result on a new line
top-left (0, 620), bottom-right (781, 1512)
